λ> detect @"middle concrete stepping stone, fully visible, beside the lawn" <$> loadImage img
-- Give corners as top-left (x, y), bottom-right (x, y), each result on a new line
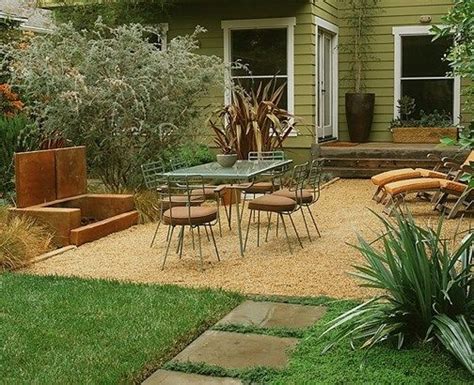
top-left (172, 330), bottom-right (298, 369)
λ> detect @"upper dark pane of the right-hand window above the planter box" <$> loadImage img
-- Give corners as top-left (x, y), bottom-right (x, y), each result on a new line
top-left (402, 35), bottom-right (452, 77)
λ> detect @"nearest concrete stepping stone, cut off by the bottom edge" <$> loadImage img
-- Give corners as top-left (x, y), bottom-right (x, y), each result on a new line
top-left (142, 370), bottom-right (242, 385)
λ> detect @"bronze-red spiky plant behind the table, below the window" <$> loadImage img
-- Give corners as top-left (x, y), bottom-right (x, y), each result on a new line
top-left (209, 80), bottom-right (296, 159)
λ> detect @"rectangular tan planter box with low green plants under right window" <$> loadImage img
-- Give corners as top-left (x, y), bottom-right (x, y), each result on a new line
top-left (390, 96), bottom-right (458, 143)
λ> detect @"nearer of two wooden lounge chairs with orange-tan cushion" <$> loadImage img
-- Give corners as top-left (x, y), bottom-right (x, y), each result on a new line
top-left (384, 178), bottom-right (474, 219)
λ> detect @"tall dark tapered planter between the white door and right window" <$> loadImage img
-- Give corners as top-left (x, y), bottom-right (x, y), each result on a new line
top-left (346, 93), bottom-right (375, 142)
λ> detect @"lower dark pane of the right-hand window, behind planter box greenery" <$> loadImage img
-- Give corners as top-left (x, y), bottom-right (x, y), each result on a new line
top-left (402, 79), bottom-right (454, 117)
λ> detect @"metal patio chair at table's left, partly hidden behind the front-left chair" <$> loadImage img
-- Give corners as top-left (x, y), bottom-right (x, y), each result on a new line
top-left (141, 162), bottom-right (202, 247)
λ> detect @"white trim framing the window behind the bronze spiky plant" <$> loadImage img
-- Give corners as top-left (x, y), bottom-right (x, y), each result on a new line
top-left (221, 17), bottom-right (296, 114)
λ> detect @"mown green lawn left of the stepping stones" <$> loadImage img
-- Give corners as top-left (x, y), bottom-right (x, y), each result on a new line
top-left (0, 274), bottom-right (241, 384)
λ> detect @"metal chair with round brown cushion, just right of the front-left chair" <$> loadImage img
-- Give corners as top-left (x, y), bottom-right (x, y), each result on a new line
top-left (244, 163), bottom-right (308, 254)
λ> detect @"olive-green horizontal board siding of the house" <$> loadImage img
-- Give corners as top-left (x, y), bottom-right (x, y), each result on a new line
top-left (43, 0), bottom-right (470, 153)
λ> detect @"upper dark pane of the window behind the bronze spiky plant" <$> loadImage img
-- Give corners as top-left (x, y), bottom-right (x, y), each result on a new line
top-left (231, 28), bottom-right (287, 76)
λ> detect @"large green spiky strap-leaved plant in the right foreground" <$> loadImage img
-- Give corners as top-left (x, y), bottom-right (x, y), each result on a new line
top-left (323, 214), bottom-right (474, 374)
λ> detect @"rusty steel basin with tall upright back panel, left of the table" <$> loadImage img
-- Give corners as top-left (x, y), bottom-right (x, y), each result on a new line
top-left (9, 147), bottom-right (138, 246)
